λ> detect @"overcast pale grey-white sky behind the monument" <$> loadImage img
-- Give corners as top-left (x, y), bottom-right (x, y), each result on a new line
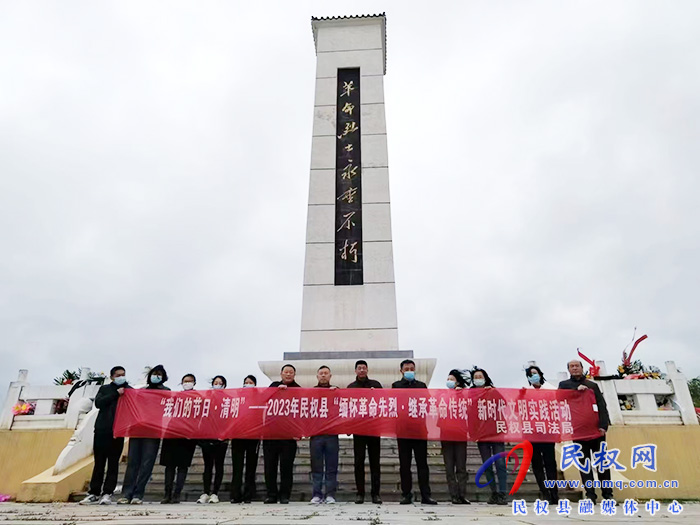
top-left (0, 0), bottom-right (700, 397)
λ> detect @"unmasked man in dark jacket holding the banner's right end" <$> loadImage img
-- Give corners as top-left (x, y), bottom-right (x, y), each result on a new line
top-left (559, 359), bottom-right (613, 505)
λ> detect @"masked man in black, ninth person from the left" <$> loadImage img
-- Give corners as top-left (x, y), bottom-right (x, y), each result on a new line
top-left (391, 359), bottom-right (437, 505)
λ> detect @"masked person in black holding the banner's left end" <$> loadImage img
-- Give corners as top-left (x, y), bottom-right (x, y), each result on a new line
top-left (80, 366), bottom-right (131, 505)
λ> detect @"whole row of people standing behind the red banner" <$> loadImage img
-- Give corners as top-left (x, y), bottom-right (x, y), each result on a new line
top-left (81, 359), bottom-right (612, 505)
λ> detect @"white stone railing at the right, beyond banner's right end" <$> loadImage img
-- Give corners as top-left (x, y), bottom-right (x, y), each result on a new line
top-left (558, 361), bottom-right (698, 425)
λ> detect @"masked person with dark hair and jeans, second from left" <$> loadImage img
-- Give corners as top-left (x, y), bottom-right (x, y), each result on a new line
top-left (117, 365), bottom-right (170, 505)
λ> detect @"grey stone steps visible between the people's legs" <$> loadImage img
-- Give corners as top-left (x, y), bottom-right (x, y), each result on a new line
top-left (72, 436), bottom-right (579, 502)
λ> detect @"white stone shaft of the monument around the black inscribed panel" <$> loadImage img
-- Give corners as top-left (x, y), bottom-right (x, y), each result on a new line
top-left (300, 17), bottom-right (399, 352)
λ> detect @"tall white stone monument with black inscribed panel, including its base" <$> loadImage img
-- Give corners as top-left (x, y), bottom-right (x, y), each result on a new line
top-left (259, 14), bottom-right (436, 387)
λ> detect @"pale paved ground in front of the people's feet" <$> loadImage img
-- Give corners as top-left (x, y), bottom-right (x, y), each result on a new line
top-left (0, 503), bottom-right (700, 525)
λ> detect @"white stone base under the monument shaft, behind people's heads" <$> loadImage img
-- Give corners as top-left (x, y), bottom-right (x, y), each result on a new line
top-left (258, 350), bottom-right (437, 388)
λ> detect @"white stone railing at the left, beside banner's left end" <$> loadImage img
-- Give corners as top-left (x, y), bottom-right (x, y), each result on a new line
top-left (0, 368), bottom-right (99, 430)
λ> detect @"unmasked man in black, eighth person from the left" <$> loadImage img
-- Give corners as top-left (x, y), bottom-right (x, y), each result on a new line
top-left (348, 359), bottom-right (382, 505)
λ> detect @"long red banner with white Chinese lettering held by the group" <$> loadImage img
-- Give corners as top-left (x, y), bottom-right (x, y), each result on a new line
top-left (114, 388), bottom-right (600, 442)
